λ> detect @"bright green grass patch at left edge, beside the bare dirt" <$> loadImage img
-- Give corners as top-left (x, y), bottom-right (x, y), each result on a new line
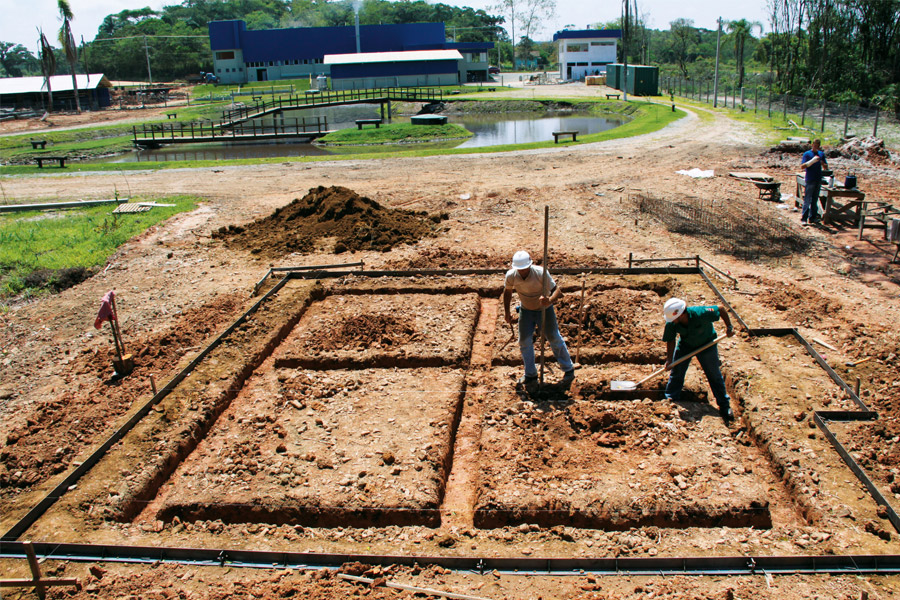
top-left (0, 196), bottom-right (198, 298)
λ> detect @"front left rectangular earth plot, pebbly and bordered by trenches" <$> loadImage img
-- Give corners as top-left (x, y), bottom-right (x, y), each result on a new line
top-left (158, 369), bottom-right (464, 527)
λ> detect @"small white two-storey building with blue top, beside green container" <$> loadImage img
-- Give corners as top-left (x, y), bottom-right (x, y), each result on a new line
top-left (553, 29), bottom-right (622, 80)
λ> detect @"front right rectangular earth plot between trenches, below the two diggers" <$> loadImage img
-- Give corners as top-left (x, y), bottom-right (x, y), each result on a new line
top-left (475, 368), bottom-right (771, 529)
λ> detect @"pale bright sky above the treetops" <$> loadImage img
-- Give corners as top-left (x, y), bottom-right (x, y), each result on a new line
top-left (0, 0), bottom-right (768, 52)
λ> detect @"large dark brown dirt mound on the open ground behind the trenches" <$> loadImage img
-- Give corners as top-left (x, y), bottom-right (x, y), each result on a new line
top-left (213, 186), bottom-right (440, 256)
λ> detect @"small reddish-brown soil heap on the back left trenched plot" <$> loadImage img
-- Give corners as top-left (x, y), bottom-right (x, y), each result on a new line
top-left (302, 314), bottom-right (416, 350)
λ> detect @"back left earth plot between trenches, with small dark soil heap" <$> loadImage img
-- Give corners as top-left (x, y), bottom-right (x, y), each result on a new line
top-left (275, 294), bottom-right (479, 369)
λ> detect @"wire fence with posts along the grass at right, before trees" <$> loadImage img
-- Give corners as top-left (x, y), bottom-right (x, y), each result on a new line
top-left (661, 76), bottom-right (900, 149)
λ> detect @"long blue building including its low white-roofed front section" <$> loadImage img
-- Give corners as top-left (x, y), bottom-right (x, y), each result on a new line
top-left (209, 21), bottom-right (494, 89)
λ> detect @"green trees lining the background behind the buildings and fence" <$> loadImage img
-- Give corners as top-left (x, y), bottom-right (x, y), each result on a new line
top-left (0, 0), bottom-right (900, 112)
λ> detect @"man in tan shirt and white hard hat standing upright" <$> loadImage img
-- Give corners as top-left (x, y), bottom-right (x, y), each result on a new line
top-left (503, 250), bottom-right (575, 386)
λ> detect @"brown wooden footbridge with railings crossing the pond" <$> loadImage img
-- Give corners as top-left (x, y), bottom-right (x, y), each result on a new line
top-left (132, 88), bottom-right (443, 148)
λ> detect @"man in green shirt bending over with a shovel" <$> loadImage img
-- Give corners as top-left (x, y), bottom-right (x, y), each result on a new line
top-left (663, 298), bottom-right (734, 423)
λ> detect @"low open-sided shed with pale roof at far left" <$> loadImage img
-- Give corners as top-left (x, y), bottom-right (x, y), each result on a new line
top-left (0, 73), bottom-right (112, 110)
